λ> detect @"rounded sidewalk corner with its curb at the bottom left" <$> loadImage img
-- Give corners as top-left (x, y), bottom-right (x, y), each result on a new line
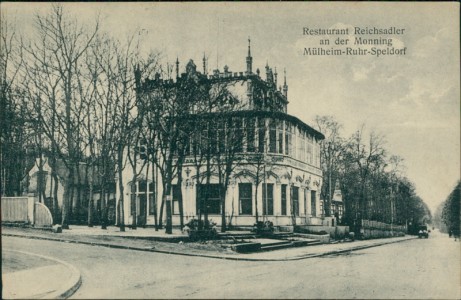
top-left (2, 248), bottom-right (81, 299)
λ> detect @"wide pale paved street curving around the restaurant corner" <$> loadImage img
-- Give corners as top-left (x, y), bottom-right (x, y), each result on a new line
top-left (2, 233), bottom-right (460, 299)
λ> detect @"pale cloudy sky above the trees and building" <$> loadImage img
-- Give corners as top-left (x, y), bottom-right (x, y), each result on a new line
top-left (1, 2), bottom-right (460, 212)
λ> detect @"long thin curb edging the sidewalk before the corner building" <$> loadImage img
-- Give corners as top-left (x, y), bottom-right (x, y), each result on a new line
top-left (2, 233), bottom-right (412, 261)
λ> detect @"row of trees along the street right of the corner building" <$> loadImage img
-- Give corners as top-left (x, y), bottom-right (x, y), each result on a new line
top-left (315, 116), bottom-right (431, 232)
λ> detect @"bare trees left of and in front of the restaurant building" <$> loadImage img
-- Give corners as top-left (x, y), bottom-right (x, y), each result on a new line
top-left (1, 5), bottom-right (253, 231)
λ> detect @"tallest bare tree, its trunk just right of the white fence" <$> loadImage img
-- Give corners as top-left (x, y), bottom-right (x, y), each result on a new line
top-left (23, 5), bottom-right (99, 229)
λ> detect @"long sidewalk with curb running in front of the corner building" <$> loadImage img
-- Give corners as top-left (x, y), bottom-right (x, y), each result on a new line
top-left (2, 225), bottom-right (416, 261)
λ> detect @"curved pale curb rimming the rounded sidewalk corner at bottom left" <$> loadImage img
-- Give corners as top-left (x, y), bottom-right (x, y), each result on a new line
top-left (2, 249), bottom-right (82, 299)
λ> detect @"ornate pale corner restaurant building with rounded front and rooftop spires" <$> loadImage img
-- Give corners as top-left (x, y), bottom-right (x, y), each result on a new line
top-left (117, 44), bottom-right (324, 226)
